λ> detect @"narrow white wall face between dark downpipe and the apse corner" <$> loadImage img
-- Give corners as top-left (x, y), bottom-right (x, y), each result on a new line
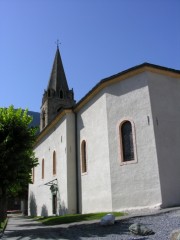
top-left (77, 91), bottom-right (112, 213)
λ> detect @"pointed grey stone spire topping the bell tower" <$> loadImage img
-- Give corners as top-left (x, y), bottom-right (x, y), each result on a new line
top-left (47, 45), bottom-right (69, 93)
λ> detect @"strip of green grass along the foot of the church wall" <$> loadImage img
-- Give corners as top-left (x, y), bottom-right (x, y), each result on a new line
top-left (36, 212), bottom-right (124, 225)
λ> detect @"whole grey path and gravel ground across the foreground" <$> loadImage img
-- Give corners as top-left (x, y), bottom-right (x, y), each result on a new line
top-left (2, 209), bottom-right (180, 240)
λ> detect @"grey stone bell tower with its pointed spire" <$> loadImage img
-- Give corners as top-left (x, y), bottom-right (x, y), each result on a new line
top-left (40, 46), bottom-right (75, 131)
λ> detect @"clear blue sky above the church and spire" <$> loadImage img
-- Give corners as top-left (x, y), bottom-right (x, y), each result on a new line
top-left (0, 0), bottom-right (180, 111)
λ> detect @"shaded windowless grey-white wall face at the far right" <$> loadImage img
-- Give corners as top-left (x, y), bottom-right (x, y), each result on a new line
top-left (148, 73), bottom-right (180, 207)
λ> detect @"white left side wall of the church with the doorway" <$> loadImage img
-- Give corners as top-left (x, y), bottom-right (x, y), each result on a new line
top-left (29, 113), bottom-right (74, 215)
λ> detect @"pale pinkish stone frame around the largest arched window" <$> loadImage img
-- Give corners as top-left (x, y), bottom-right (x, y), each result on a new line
top-left (118, 118), bottom-right (138, 165)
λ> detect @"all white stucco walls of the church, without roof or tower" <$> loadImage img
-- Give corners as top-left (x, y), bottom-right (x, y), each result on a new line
top-left (29, 66), bottom-right (180, 215)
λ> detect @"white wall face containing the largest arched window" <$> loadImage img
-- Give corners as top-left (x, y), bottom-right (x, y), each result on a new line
top-left (106, 73), bottom-right (161, 211)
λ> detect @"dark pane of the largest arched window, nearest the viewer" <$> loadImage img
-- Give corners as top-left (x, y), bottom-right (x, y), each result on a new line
top-left (119, 120), bottom-right (136, 162)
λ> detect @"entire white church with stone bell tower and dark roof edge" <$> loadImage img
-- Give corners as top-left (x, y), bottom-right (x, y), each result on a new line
top-left (28, 47), bottom-right (180, 216)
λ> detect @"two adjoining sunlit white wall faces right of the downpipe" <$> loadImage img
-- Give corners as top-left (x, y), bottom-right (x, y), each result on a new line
top-left (77, 73), bottom-right (162, 212)
